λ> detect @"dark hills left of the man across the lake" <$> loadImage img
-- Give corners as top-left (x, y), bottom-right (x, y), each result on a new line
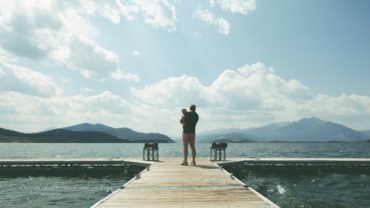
top-left (0, 123), bottom-right (174, 143)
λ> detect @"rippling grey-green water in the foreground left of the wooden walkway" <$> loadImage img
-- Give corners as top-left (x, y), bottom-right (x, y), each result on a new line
top-left (0, 176), bottom-right (127, 208)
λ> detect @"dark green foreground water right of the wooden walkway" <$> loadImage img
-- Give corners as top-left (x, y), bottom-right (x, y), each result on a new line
top-left (227, 166), bottom-right (370, 208)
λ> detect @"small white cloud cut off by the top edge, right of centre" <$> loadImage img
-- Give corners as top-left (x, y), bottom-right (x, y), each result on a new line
top-left (210, 0), bottom-right (256, 15)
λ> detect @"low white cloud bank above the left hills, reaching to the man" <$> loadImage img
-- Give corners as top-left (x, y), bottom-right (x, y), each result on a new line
top-left (0, 90), bottom-right (185, 134)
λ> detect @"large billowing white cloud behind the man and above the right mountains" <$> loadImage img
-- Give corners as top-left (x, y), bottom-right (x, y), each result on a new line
top-left (131, 63), bottom-right (370, 130)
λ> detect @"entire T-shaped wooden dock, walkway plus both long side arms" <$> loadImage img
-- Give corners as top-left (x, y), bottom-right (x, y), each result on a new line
top-left (0, 158), bottom-right (370, 208)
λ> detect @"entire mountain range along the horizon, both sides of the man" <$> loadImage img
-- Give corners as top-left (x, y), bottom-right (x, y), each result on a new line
top-left (0, 117), bottom-right (370, 143)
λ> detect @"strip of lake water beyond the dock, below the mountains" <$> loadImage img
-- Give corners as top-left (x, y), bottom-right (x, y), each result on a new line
top-left (0, 143), bottom-right (370, 158)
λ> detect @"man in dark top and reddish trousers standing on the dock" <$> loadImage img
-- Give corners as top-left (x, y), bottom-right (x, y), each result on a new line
top-left (181, 105), bottom-right (199, 165)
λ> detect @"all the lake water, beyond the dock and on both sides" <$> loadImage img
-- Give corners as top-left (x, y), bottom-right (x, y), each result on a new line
top-left (0, 143), bottom-right (370, 208)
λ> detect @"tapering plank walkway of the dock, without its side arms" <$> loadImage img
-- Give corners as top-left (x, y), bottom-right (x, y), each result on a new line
top-left (92, 158), bottom-right (278, 208)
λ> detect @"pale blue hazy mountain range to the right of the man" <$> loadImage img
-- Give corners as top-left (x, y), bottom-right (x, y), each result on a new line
top-left (197, 117), bottom-right (370, 142)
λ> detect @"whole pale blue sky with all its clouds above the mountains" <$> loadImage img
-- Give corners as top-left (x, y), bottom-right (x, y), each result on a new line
top-left (0, 0), bottom-right (370, 136)
